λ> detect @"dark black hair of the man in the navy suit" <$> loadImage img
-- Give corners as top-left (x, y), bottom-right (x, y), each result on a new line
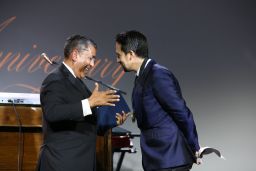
top-left (116, 30), bottom-right (148, 58)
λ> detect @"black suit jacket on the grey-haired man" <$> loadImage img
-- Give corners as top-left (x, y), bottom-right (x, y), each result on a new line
top-left (37, 64), bottom-right (97, 171)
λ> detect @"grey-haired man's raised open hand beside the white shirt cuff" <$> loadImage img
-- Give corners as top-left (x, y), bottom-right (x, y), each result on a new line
top-left (88, 83), bottom-right (120, 108)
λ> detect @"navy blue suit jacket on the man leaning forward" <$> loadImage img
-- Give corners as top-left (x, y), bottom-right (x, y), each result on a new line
top-left (132, 60), bottom-right (200, 171)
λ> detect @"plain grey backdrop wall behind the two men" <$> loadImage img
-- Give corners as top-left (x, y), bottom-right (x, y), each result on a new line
top-left (0, 0), bottom-right (256, 171)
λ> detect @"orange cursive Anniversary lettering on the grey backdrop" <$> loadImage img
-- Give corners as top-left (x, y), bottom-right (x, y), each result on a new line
top-left (0, 16), bottom-right (124, 92)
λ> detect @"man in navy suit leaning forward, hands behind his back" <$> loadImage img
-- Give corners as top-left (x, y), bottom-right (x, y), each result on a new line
top-left (116, 31), bottom-right (200, 171)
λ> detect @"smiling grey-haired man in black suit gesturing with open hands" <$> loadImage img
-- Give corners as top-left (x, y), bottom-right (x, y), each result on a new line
top-left (38, 35), bottom-right (125, 171)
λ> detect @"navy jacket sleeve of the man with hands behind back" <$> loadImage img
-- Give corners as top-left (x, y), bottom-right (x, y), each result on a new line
top-left (153, 68), bottom-right (200, 152)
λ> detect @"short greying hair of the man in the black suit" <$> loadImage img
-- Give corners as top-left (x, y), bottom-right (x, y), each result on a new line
top-left (64, 35), bottom-right (97, 58)
